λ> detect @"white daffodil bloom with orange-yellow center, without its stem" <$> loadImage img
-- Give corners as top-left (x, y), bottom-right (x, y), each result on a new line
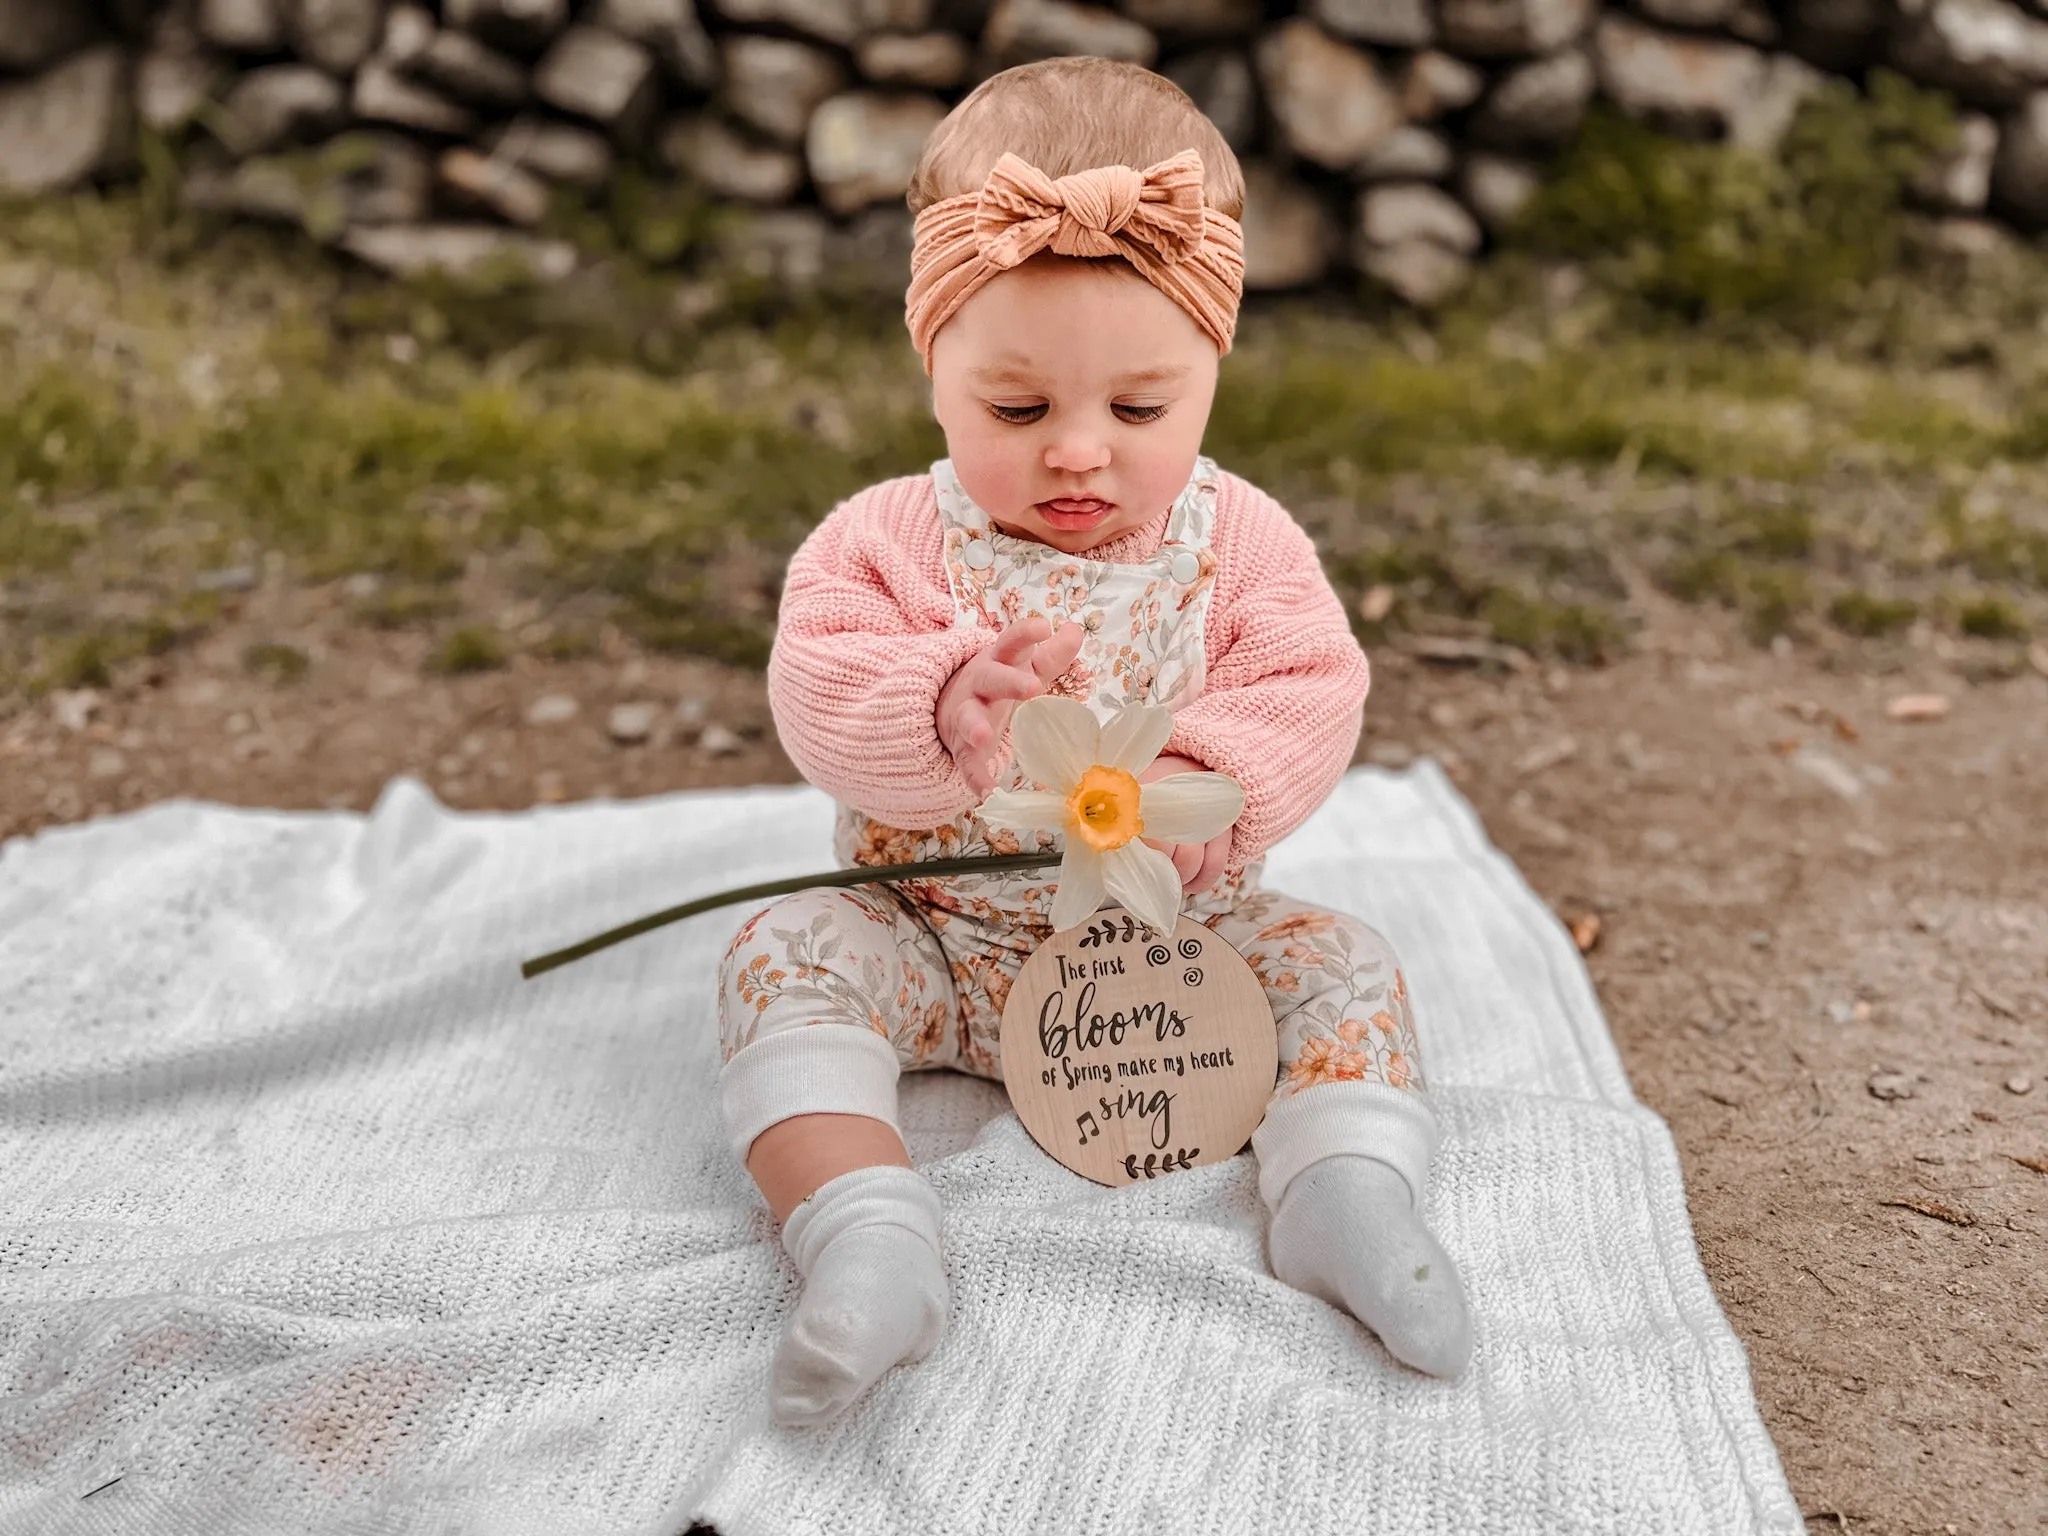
top-left (975, 694), bottom-right (1245, 934)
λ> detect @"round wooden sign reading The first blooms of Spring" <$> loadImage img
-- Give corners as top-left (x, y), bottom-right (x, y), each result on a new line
top-left (1004, 907), bottom-right (1280, 1186)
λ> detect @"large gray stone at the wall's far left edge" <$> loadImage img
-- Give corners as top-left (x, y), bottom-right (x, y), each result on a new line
top-left (0, 43), bottom-right (133, 197)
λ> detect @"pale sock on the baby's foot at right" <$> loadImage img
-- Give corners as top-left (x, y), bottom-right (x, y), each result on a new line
top-left (1266, 1155), bottom-right (1473, 1376)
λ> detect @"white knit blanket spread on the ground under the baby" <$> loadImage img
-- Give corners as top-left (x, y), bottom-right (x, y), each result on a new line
top-left (0, 766), bottom-right (1800, 1536)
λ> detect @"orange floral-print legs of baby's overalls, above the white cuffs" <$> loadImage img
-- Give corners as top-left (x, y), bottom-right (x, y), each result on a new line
top-left (719, 885), bottom-right (1423, 1102)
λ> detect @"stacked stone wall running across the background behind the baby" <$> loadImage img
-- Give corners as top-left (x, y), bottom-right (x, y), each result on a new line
top-left (0, 0), bottom-right (2048, 305)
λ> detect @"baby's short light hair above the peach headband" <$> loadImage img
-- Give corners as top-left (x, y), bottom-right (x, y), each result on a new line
top-left (907, 57), bottom-right (1245, 219)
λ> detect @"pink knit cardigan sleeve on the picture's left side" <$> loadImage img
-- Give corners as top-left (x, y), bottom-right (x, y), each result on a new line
top-left (768, 475), bottom-right (991, 829)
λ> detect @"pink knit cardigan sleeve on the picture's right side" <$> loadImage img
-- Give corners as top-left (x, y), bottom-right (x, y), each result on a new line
top-left (1165, 475), bottom-right (1372, 874)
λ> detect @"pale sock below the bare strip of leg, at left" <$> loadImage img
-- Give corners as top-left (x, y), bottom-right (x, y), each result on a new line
top-left (770, 1163), bottom-right (950, 1425)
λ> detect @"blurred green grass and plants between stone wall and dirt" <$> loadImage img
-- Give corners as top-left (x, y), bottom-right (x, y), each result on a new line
top-left (0, 76), bottom-right (2048, 692)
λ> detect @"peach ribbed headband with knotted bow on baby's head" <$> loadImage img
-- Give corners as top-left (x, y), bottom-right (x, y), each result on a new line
top-left (903, 150), bottom-right (1245, 373)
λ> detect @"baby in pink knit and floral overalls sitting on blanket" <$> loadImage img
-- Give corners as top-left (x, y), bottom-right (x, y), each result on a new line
top-left (719, 57), bottom-right (1470, 1423)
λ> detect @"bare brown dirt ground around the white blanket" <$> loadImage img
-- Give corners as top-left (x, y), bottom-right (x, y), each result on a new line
top-left (0, 582), bottom-right (2048, 1534)
